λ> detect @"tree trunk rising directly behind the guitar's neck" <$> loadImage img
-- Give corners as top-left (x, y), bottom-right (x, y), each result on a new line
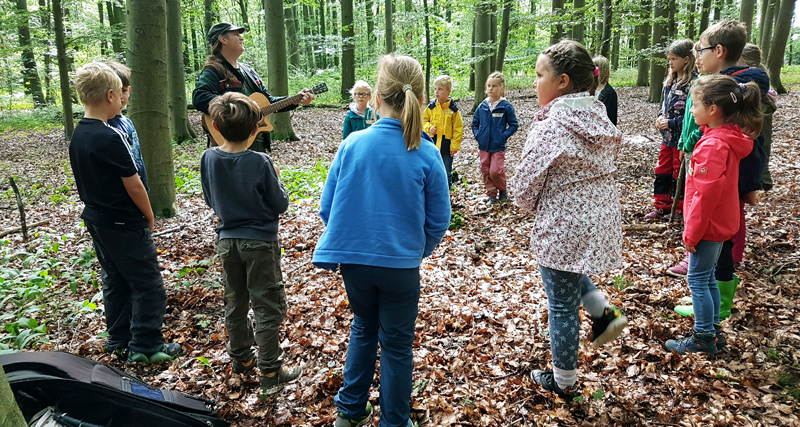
top-left (264, 0), bottom-right (298, 141)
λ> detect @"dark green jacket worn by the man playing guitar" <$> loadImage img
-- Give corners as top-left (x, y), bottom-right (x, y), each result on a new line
top-left (192, 55), bottom-right (297, 151)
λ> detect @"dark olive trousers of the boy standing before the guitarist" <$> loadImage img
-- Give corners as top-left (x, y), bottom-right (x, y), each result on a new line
top-left (217, 239), bottom-right (286, 374)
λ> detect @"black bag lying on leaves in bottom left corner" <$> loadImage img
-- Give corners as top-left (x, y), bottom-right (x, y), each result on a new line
top-left (0, 351), bottom-right (230, 427)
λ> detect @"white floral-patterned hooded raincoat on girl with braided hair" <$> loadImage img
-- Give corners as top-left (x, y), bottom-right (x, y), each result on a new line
top-left (512, 92), bottom-right (622, 274)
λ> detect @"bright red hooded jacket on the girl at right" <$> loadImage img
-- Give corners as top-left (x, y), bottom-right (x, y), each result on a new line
top-left (683, 123), bottom-right (753, 246)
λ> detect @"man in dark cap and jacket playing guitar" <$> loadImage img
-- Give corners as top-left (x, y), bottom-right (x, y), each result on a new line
top-left (192, 22), bottom-right (314, 152)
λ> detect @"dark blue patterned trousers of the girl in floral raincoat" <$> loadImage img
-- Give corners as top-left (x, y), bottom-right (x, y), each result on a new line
top-left (539, 265), bottom-right (597, 370)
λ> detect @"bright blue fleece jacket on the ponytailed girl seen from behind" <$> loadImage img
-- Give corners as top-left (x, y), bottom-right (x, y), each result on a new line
top-left (312, 118), bottom-right (450, 269)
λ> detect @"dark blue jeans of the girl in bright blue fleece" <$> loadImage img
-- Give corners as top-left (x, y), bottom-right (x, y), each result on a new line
top-left (334, 264), bottom-right (419, 427)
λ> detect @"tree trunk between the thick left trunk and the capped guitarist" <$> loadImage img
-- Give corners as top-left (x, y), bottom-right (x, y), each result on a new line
top-left (166, 0), bottom-right (196, 144)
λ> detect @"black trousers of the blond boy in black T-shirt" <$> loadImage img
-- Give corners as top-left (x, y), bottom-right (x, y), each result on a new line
top-left (86, 223), bottom-right (167, 356)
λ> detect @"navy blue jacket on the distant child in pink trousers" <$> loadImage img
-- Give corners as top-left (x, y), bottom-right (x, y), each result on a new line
top-left (472, 99), bottom-right (519, 153)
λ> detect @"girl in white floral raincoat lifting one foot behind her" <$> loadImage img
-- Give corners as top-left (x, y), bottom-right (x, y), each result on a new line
top-left (513, 40), bottom-right (627, 399)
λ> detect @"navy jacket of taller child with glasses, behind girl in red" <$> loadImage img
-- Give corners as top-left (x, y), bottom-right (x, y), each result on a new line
top-left (720, 65), bottom-right (769, 197)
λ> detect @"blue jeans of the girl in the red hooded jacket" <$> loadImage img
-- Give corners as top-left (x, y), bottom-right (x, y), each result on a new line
top-left (686, 240), bottom-right (723, 335)
